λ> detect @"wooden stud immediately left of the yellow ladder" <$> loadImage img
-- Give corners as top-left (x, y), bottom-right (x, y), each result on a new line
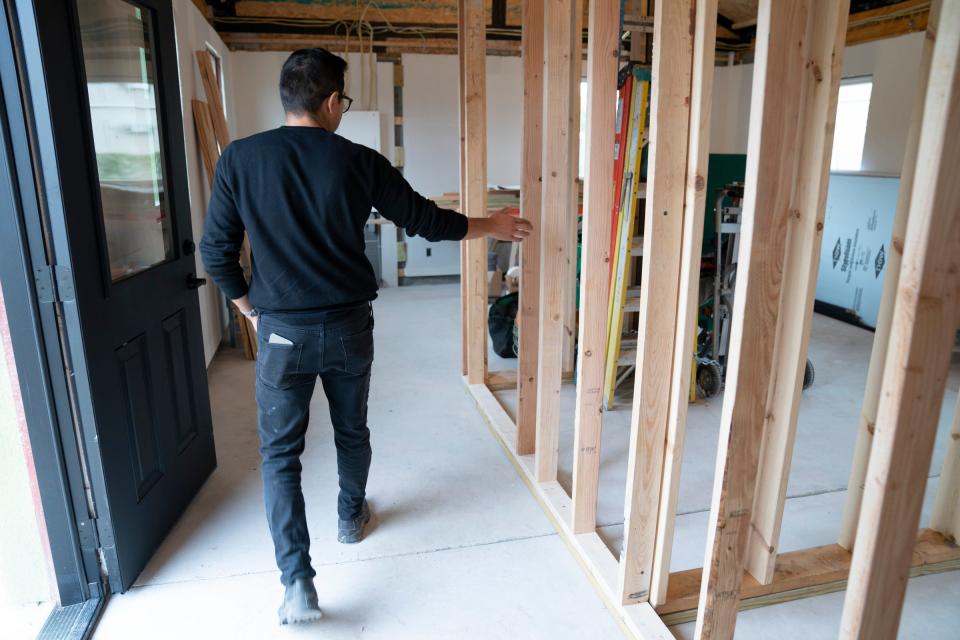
top-left (571, 0), bottom-right (620, 533)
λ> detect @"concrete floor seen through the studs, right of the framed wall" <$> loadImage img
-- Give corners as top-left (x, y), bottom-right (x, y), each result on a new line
top-left (490, 304), bottom-right (960, 640)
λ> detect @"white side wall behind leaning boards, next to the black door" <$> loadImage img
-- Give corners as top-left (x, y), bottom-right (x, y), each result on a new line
top-left (173, 0), bottom-right (236, 366)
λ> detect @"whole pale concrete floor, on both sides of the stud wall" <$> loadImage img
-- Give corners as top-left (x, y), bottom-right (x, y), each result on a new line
top-left (95, 285), bottom-right (960, 640)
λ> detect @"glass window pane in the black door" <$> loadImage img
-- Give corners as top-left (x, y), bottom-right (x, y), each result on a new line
top-left (77, 0), bottom-right (172, 281)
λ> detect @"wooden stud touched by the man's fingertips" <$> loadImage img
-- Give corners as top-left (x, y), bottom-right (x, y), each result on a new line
top-left (516, 0), bottom-right (543, 455)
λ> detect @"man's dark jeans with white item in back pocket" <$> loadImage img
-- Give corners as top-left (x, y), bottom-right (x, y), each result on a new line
top-left (257, 303), bottom-right (373, 585)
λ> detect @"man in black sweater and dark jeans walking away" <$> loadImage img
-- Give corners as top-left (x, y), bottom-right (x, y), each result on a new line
top-left (200, 49), bottom-right (531, 624)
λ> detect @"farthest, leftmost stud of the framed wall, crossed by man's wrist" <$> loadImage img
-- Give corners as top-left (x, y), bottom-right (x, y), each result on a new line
top-left (459, 0), bottom-right (487, 384)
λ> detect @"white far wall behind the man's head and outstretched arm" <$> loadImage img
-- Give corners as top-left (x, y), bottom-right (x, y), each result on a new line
top-left (232, 51), bottom-right (523, 276)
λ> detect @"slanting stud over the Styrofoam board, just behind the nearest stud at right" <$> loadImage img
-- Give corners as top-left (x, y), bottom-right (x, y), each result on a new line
top-left (837, 0), bottom-right (940, 549)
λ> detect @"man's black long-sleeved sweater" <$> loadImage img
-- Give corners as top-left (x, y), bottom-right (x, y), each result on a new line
top-left (200, 127), bottom-right (467, 311)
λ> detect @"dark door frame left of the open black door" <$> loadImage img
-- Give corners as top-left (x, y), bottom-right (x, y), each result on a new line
top-left (0, 0), bottom-right (105, 612)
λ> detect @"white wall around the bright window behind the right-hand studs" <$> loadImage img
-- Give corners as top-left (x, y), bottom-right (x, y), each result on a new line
top-left (710, 33), bottom-right (924, 175)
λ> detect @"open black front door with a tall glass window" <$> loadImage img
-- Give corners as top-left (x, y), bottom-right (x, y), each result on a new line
top-left (16, 0), bottom-right (216, 591)
